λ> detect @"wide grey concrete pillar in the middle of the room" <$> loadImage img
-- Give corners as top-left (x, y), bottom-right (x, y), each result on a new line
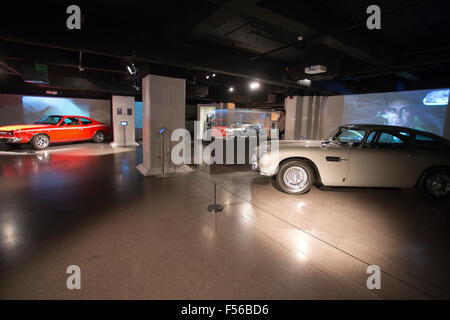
top-left (137, 75), bottom-right (187, 176)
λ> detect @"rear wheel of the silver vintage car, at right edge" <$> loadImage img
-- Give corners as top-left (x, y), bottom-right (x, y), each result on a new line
top-left (418, 169), bottom-right (450, 201)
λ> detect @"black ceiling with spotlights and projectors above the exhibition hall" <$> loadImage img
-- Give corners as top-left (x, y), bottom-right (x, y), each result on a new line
top-left (0, 0), bottom-right (450, 106)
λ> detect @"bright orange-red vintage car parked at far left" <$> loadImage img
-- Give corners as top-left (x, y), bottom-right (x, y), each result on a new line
top-left (0, 115), bottom-right (111, 150)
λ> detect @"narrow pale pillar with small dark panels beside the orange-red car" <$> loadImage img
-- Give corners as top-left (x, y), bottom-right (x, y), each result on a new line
top-left (111, 96), bottom-right (138, 147)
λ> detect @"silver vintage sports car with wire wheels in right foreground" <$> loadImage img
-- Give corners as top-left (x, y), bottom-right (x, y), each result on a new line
top-left (253, 124), bottom-right (450, 199)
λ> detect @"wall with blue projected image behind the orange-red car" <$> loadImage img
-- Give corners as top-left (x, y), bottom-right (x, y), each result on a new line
top-left (0, 94), bottom-right (111, 125)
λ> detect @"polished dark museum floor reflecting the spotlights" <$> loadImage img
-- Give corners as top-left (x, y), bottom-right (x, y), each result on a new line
top-left (0, 143), bottom-right (450, 299)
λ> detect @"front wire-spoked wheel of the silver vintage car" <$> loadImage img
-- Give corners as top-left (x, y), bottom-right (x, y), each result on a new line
top-left (276, 160), bottom-right (314, 194)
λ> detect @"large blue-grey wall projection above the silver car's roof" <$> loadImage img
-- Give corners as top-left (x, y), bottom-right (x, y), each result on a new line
top-left (343, 89), bottom-right (450, 135)
